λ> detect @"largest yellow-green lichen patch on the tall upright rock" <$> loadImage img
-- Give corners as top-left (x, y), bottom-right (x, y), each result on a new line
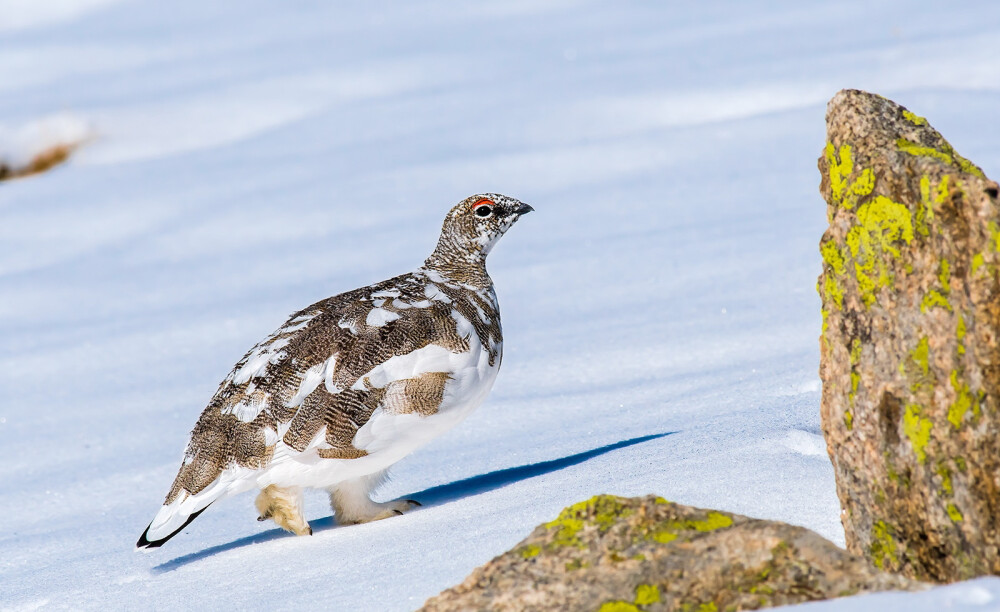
top-left (846, 196), bottom-right (913, 306)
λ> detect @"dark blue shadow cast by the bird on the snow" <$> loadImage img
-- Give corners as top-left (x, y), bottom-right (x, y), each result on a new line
top-left (151, 431), bottom-right (677, 574)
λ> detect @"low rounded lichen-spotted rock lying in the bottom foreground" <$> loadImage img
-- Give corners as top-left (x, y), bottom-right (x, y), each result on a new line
top-left (422, 495), bottom-right (922, 612)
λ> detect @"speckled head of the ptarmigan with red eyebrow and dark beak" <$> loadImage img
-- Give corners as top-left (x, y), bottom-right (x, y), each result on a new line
top-left (427, 193), bottom-right (534, 268)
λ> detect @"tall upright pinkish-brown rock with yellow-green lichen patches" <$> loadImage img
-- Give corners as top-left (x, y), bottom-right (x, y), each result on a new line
top-left (818, 90), bottom-right (1000, 581)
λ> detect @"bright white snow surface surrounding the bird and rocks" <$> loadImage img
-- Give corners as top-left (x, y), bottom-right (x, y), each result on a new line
top-left (0, 0), bottom-right (1000, 611)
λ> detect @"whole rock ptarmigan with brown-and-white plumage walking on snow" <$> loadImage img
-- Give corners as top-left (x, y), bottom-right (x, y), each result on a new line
top-left (136, 193), bottom-right (532, 549)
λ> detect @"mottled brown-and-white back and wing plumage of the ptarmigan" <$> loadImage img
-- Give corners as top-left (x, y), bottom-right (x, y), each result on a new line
top-left (165, 275), bottom-right (480, 504)
